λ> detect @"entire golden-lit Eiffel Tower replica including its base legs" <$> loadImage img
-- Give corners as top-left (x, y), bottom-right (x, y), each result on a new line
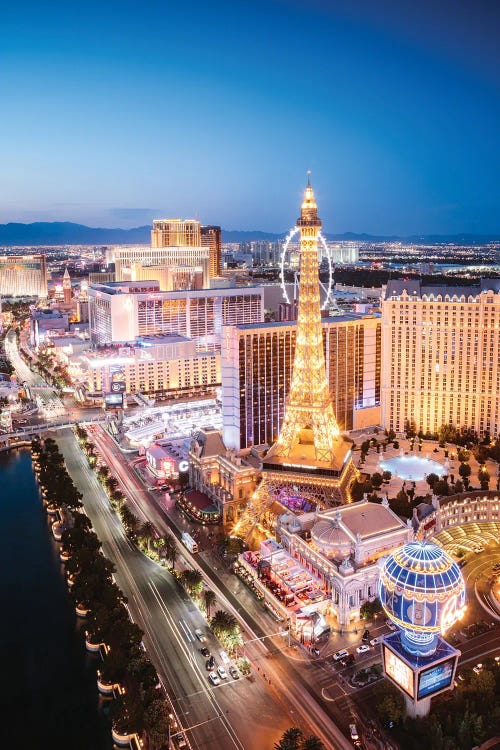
top-left (234, 173), bottom-right (356, 537)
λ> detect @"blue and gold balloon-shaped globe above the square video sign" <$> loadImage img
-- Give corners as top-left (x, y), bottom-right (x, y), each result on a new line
top-left (379, 541), bottom-right (465, 654)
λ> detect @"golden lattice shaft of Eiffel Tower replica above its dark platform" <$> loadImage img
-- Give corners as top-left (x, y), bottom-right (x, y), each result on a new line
top-left (266, 172), bottom-right (340, 463)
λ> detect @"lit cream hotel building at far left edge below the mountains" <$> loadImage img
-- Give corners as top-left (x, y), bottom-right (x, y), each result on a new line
top-left (0, 254), bottom-right (47, 298)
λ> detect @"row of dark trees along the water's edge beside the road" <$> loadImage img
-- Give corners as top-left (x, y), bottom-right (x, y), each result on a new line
top-left (32, 439), bottom-right (170, 748)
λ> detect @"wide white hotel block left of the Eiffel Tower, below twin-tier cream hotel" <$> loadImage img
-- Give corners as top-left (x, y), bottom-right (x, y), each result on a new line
top-left (88, 281), bottom-right (264, 351)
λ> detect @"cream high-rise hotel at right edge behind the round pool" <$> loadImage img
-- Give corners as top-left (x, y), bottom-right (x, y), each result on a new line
top-left (381, 279), bottom-right (500, 437)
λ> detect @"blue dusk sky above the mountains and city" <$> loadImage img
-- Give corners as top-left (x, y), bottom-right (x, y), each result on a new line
top-left (0, 0), bottom-right (500, 235)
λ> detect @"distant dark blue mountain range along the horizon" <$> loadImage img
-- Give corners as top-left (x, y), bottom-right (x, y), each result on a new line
top-left (0, 221), bottom-right (500, 247)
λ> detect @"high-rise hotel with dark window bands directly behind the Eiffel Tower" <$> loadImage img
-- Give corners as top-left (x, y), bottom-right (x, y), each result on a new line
top-left (222, 315), bottom-right (381, 449)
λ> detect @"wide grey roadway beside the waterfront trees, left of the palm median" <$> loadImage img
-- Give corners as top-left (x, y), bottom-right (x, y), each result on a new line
top-left (58, 431), bottom-right (291, 750)
